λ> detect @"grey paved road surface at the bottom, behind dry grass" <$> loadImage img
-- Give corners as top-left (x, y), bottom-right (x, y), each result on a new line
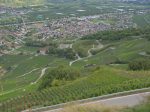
top-left (44, 92), bottom-right (150, 112)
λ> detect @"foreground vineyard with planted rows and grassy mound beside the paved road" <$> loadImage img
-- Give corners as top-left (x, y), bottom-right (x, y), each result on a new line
top-left (0, 67), bottom-right (150, 112)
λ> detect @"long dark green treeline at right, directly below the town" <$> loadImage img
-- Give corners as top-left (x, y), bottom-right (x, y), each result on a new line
top-left (82, 27), bottom-right (150, 41)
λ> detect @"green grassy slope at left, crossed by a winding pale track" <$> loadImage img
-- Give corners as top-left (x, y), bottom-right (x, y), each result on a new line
top-left (0, 55), bottom-right (69, 99)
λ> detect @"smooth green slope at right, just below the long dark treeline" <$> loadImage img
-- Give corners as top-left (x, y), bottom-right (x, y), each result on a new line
top-left (74, 39), bottom-right (150, 67)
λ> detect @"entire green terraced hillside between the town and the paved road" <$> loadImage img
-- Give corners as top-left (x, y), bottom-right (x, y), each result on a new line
top-left (0, 29), bottom-right (150, 112)
